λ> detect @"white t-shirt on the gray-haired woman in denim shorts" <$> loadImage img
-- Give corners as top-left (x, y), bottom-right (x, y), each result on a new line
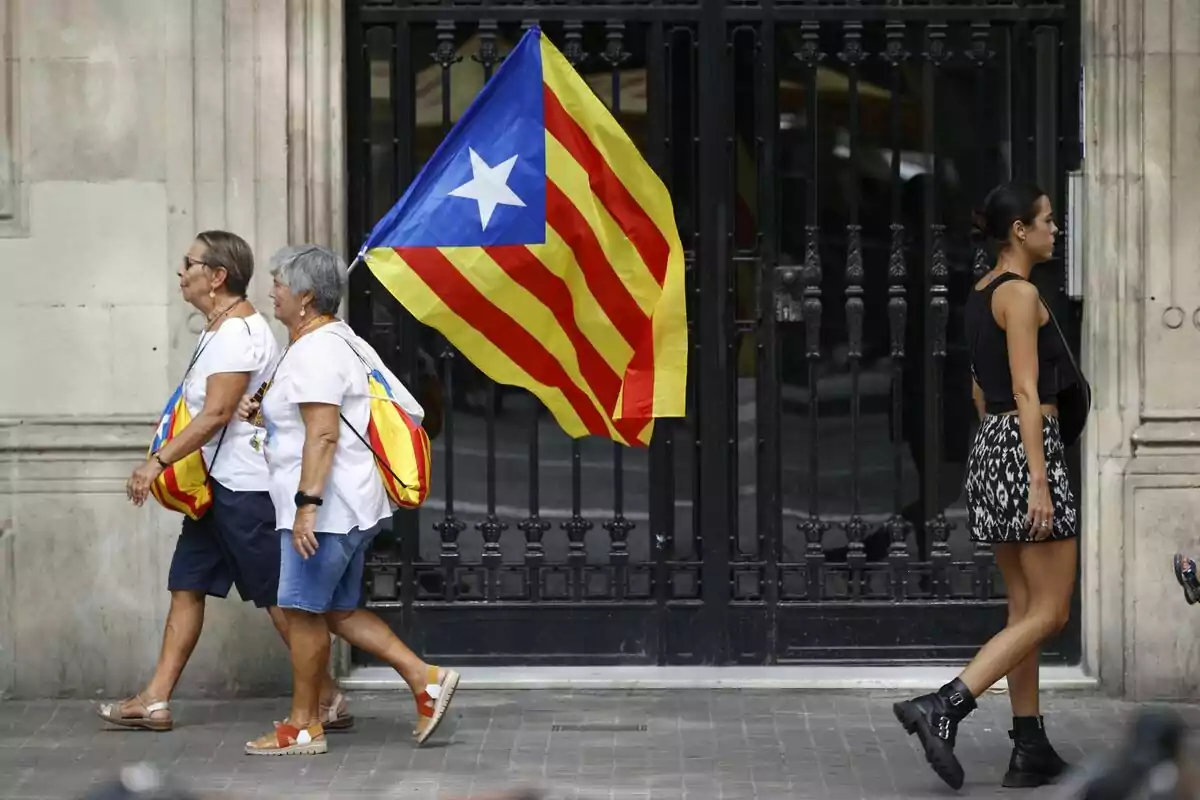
top-left (263, 320), bottom-right (425, 534)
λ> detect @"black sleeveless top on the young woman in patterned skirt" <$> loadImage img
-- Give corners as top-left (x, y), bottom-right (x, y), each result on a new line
top-left (964, 272), bottom-right (1076, 414)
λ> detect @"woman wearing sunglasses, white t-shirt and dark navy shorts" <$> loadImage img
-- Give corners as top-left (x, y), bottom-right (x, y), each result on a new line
top-left (100, 230), bottom-right (354, 732)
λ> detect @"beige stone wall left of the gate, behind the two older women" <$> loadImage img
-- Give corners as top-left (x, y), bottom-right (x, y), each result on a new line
top-left (0, 0), bottom-right (344, 696)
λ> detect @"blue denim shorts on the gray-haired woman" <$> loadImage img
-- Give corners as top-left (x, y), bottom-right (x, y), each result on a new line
top-left (278, 525), bottom-right (380, 614)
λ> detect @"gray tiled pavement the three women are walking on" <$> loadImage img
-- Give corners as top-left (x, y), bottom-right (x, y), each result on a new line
top-left (0, 691), bottom-right (1200, 800)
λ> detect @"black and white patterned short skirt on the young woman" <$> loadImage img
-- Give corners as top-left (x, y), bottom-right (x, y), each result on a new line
top-left (966, 414), bottom-right (1079, 543)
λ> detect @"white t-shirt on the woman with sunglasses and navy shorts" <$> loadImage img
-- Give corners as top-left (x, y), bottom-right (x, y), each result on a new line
top-left (184, 314), bottom-right (280, 492)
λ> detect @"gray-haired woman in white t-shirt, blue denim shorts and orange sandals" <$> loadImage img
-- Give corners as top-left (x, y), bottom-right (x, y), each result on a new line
top-left (239, 246), bottom-right (458, 756)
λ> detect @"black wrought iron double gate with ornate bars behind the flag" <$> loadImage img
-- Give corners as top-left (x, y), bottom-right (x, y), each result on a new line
top-left (347, 0), bottom-right (1079, 664)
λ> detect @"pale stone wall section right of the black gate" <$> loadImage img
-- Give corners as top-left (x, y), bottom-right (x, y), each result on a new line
top-left (1082, 0), bottom-right (1200, 699)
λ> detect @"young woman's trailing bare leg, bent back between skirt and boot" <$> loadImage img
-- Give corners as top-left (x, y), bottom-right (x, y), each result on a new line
top-left (959, 539), bottom-right (1078, 697)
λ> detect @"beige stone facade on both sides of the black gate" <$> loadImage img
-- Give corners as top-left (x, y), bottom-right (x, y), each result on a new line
top-left (0, 0), bottom-right (1200, 698)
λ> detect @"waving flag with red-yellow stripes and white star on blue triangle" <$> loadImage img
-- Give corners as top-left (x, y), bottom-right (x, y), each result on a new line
top-left (359, 28), bottom-right (688, 445)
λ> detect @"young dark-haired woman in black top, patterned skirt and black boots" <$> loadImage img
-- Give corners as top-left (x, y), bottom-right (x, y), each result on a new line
top-left (895, 184), bottom-right (1078, 789)
